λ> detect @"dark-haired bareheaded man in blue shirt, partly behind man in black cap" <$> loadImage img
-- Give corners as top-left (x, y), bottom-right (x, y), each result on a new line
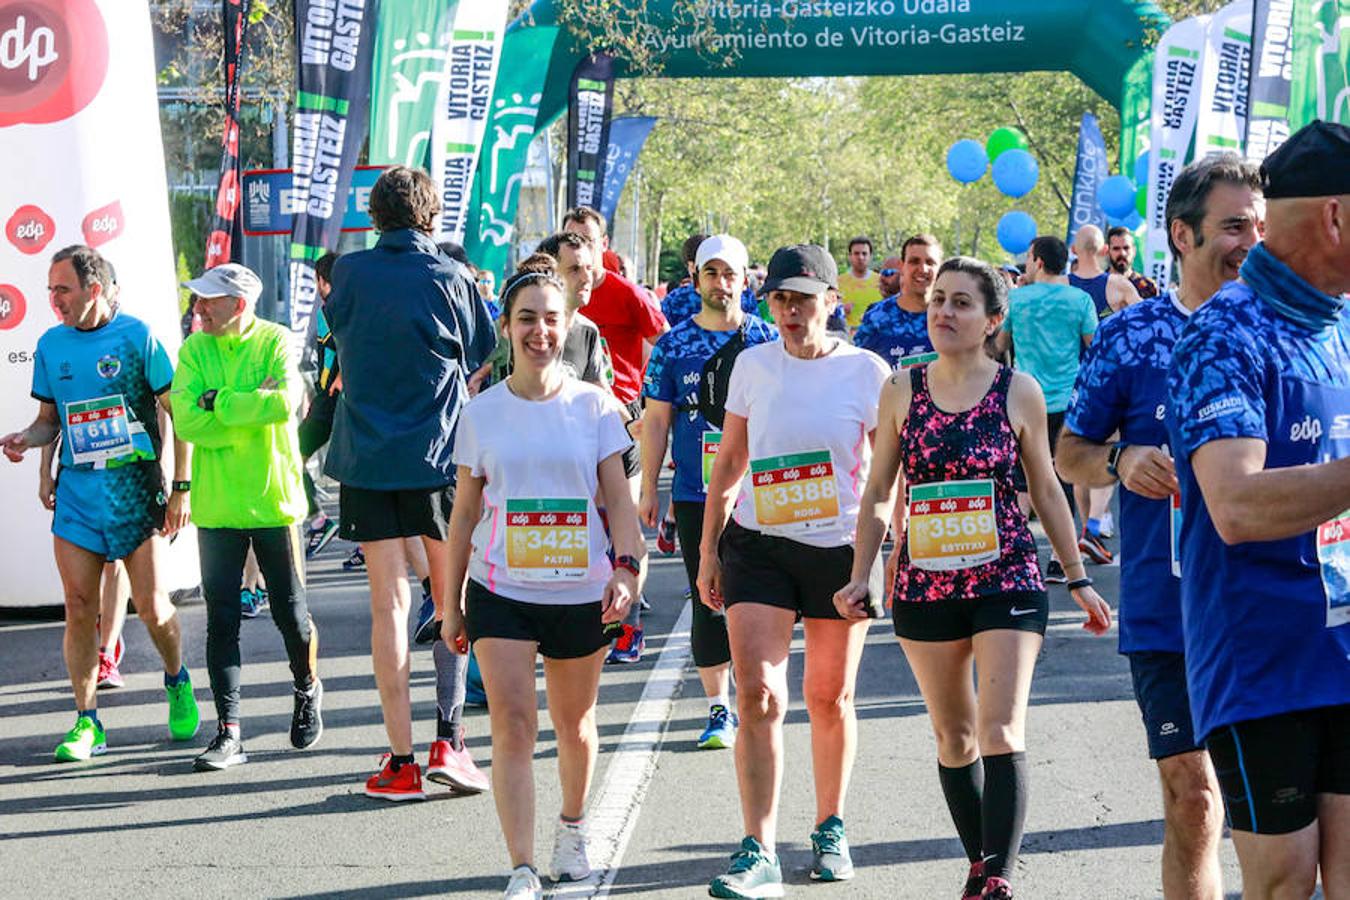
top-left (1056, 154), bottom-right (1261, 900)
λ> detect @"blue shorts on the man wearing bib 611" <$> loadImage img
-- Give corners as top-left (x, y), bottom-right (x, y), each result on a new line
top-left (51, 460), bottom-right (169, 561)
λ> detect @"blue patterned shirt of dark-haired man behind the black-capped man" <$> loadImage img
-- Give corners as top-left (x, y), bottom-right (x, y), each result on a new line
top-left (1064, 291), bottom-right (1191, 653)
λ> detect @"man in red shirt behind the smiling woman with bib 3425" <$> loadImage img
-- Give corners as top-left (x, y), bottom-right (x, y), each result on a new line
top-left (563, 206), bottom-right (670, 407)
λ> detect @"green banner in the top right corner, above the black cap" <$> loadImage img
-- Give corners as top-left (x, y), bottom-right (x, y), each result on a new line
top-left (1289, 0), bottom-right (1350, 132)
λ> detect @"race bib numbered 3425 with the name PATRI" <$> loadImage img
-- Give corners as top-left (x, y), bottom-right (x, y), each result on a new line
top-left (506, 499), bottom-right (590, 582)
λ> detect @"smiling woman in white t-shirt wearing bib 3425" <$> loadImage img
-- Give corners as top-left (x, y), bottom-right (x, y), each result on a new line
top-left (441, 271), bottom-right (645, 897)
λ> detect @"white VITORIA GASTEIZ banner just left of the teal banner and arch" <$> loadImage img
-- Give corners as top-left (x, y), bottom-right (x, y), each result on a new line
top-left (431, 0), bottom-right (508, 244)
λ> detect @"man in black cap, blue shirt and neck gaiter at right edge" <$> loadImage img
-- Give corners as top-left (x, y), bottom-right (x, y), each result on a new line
top-left (1168, 121), bottom-right (1350, 897)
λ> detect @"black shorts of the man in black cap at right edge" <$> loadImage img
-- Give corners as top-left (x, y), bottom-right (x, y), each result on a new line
top-left (1204, 703), bottom-right (1350, 834)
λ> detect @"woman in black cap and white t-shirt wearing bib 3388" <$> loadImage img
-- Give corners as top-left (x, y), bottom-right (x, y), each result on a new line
top-left (698, 244), bottom-right (890, 897)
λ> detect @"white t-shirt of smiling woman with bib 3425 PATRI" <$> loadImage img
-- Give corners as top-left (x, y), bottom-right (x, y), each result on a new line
top-left (455, 378), bottom-right (633, 606)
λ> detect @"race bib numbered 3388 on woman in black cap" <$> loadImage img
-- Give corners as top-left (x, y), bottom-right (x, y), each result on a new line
top-left (751, 449), bottom-right (840, 534)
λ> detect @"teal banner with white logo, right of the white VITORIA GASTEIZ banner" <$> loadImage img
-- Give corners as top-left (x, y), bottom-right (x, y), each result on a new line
top-left (464, 26), bottom-right (559, 278)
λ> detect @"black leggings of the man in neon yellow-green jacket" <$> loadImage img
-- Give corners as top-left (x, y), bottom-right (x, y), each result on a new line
top-left (197, 528), bottom-right (315, 723)
